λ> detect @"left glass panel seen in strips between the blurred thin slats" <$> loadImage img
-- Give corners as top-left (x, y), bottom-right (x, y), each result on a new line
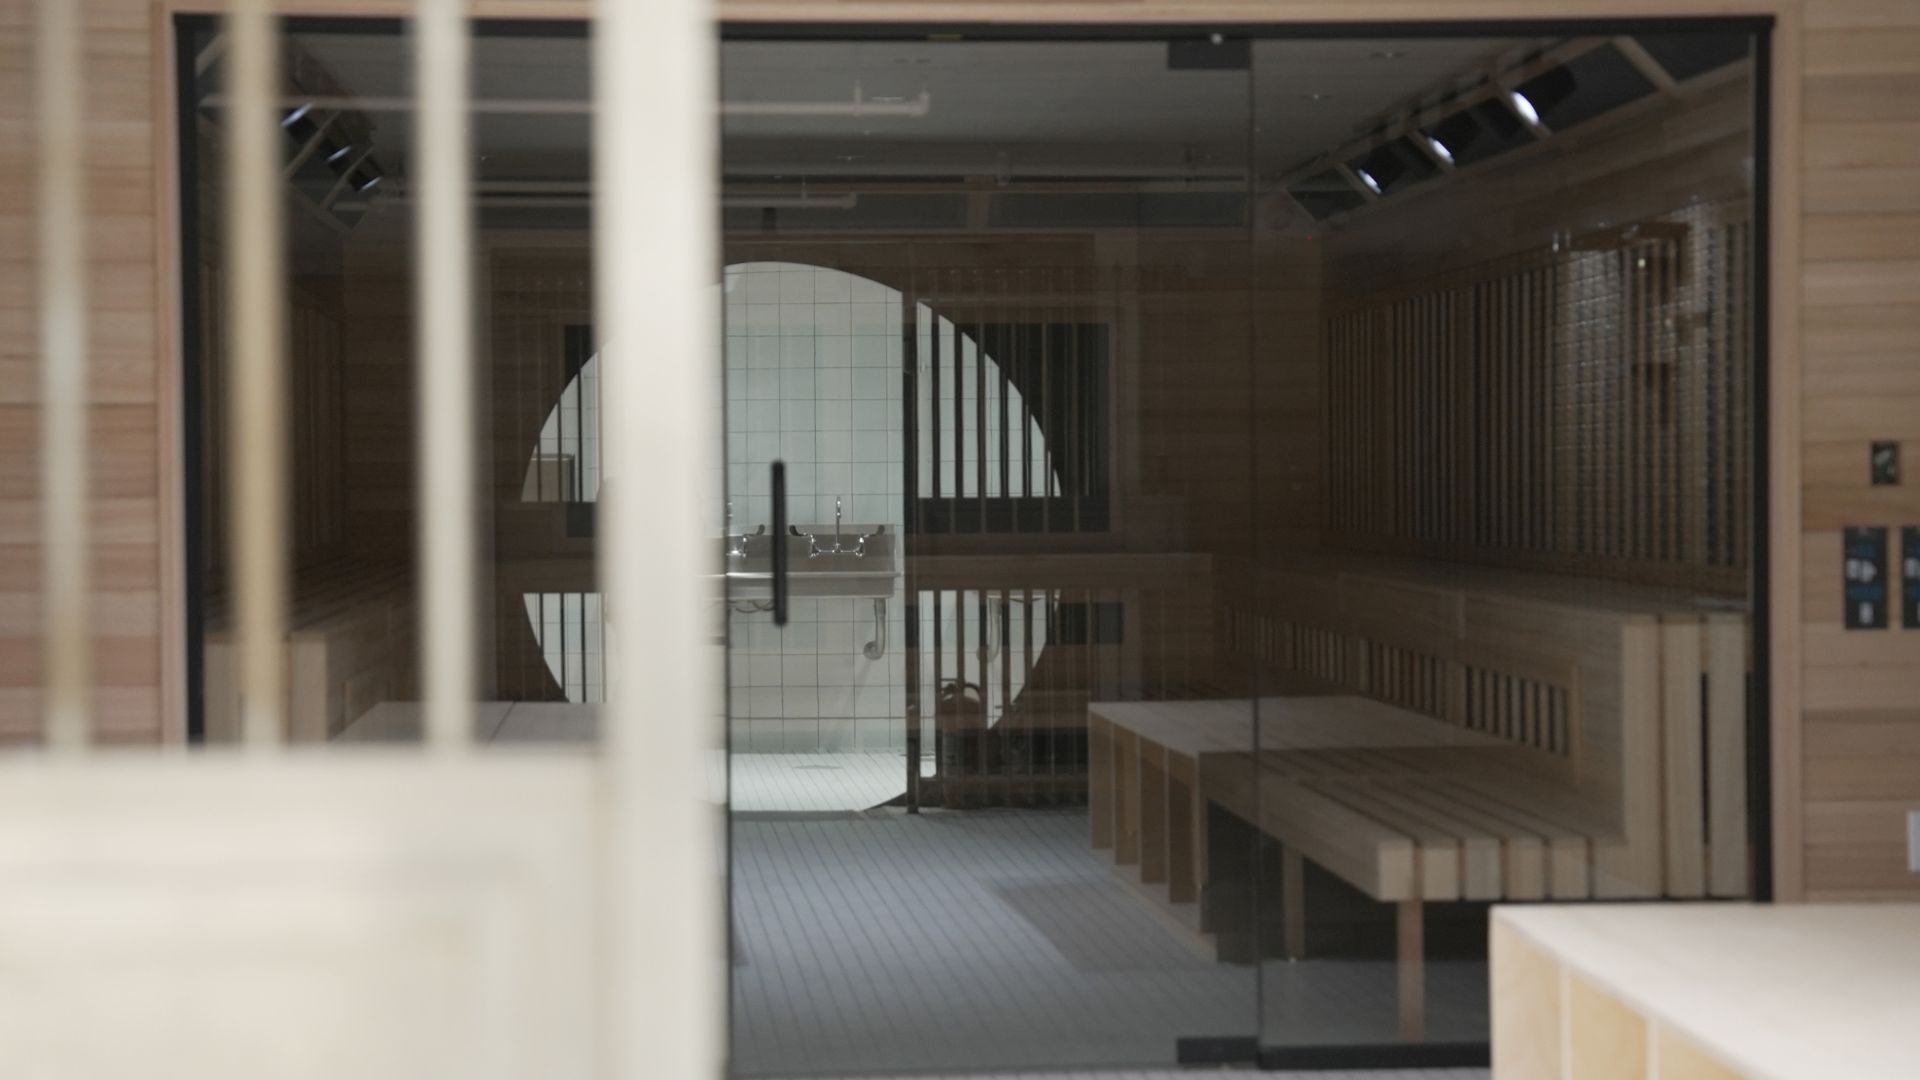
top-left (182, 19), bottom-right (607, 742)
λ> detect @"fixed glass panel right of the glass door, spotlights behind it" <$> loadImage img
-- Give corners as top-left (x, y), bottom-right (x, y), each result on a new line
top-left (1225, 35), bottom-right (1755, 1065)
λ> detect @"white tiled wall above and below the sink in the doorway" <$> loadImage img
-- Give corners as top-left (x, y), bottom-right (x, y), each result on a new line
top-left (726, 263), bottom-right (906, 751)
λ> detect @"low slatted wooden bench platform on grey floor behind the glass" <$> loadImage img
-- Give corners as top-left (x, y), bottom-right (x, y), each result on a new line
top-left (1087, 696), bottom-right (1609, 1040)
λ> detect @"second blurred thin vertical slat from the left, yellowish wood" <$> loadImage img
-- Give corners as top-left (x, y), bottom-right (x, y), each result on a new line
top-left (227, 0), bottom-right (288, 746)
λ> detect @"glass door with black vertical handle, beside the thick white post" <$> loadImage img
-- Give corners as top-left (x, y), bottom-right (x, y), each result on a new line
top-left (724, 38), bottom-right (1256, 1076)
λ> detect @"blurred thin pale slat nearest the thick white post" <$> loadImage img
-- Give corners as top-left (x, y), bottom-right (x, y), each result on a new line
top-left (415, 0), bottom-right (476, 749)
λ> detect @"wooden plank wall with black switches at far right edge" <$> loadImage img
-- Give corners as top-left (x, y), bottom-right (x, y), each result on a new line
top-left (1804, 0), bottom-right (1920, 897)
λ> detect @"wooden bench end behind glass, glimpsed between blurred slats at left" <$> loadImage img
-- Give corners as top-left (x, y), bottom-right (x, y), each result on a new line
top-left (205, 561), bottom-right (417, 742)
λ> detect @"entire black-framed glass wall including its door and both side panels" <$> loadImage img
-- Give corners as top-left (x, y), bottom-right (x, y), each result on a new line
top-left (182, 19), bottom-right (1764, 1076)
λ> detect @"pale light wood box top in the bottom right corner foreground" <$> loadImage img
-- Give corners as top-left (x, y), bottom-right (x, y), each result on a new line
top-left (1492, 903), bottom-right (1920, 1080)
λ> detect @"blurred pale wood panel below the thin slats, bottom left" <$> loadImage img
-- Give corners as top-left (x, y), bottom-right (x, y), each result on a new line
top-left (0, 749), bottom-right (605, 1080)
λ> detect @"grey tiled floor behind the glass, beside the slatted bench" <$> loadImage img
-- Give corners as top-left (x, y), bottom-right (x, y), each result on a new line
top-left (733, 811), bottom-right (1484, 1080)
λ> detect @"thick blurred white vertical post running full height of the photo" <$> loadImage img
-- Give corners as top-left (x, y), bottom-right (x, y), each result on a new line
top-left (591, 0), bottom-right (726, 1080)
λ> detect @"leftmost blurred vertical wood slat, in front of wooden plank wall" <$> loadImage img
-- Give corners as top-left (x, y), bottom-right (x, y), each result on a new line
top-left (35, 0), bottom-right (92, 749)
